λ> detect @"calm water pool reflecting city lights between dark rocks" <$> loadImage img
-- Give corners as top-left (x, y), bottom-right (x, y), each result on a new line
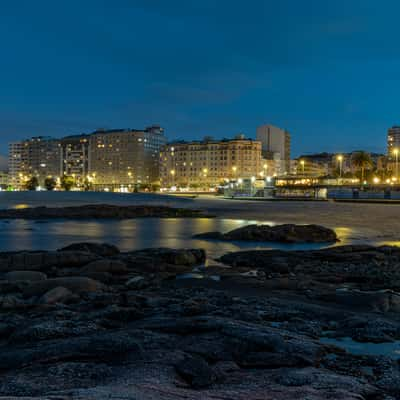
top-left (0, 218), bottom-right (349, 258)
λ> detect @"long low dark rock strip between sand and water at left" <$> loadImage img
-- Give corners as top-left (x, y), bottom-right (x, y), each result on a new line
top-left (0, 204), bottom-right (212, 220)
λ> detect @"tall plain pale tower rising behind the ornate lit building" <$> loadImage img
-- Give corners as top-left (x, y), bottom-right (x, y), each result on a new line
top-left (257, 125), bottom-right (290, 174)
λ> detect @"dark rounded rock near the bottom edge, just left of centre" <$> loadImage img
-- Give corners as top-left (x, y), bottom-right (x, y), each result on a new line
top-left (175, 355), bottom-right (217, 389)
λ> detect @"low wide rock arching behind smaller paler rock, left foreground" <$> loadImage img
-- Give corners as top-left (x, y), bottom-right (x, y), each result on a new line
top-left (22, 276), bottom-right (103, 297)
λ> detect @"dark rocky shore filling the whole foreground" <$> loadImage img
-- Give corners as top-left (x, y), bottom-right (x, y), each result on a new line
top-left (0, 243), bottom-right (400, 400)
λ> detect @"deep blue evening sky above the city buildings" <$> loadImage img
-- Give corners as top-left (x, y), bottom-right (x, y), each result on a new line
top-left (0, 0), bottom-right (400, 155)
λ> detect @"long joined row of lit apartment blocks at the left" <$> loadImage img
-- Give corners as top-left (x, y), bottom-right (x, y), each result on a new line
top-left (9, 126), bottom-right (166, 190)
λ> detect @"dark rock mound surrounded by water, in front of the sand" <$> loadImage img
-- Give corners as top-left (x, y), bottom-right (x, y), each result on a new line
top-left (194, 224), bottom-right (338, 243)
